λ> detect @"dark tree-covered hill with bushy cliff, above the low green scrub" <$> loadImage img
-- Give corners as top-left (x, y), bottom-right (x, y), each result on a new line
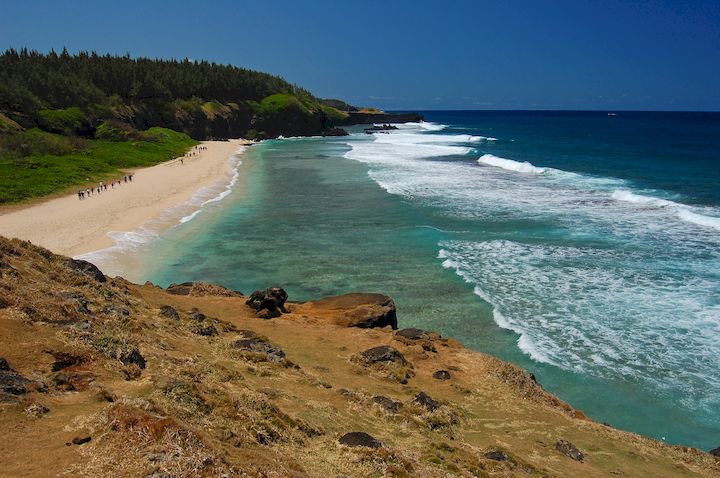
top-left (0, 49), bottom-right (349, 139)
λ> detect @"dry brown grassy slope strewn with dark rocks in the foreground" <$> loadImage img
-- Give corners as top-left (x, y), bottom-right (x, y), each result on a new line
top-left (0, 238), bottom-right (720, 478)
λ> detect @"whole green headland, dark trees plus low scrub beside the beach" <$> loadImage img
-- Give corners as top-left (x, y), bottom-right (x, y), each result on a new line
top-left (0, 49), bottom-right (358, 204)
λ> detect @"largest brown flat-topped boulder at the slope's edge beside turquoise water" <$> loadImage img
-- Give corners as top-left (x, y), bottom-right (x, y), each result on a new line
top-left (307, 293), bottom-right (397, 330)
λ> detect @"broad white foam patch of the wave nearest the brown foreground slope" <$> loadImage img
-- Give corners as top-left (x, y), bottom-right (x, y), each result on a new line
top-left (438, 240), bottom-right (720, 407)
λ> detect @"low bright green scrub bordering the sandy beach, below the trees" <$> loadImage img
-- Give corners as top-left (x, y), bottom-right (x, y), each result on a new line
top-left (0, 128), bottom-right (197, 204)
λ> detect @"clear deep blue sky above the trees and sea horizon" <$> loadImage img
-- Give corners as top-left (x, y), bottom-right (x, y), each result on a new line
top-left (0, 0), bottom-right (720, 111)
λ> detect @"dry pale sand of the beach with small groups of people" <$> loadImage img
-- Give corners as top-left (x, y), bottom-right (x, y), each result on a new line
top-left (0, 139), bottom-right (251, 256)
